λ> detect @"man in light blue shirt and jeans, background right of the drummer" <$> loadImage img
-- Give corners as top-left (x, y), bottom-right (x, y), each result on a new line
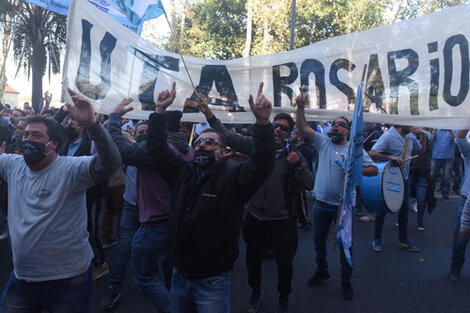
top-left (431, 129), bottom-right (455, 200)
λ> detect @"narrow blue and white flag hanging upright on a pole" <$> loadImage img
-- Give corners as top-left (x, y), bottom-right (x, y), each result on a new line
top-left (336, 81), bottom-right (364, 267)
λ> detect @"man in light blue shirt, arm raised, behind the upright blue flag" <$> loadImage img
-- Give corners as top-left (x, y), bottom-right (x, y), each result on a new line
top-left (296, 89), bottom-right (378, 300)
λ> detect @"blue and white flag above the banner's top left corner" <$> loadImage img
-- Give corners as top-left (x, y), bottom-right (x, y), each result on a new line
top-left (26, 0), bottom-right (165, 34)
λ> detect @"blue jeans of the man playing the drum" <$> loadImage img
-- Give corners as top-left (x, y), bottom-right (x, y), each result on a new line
top-left (374, 178), bottom-right (410, 242)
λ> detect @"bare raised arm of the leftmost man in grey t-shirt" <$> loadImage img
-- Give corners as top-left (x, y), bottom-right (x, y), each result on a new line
top-left (66, 88), bottom-right (121, 183)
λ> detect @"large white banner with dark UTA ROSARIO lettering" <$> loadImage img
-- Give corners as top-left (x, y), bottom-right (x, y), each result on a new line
top-left (64, 0), bottom-right (470, 129)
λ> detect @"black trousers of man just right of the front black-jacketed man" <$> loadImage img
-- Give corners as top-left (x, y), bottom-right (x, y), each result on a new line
top-left (243, 213), bottom-right (297, 299)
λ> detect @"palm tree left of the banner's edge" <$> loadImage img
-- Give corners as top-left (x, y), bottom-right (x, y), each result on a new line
top-left (13, 2), bottom-right (66, 112)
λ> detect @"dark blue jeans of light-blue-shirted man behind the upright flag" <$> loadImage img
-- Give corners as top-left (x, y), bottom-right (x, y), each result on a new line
top-left (312, 201), bottom-right (352, 282)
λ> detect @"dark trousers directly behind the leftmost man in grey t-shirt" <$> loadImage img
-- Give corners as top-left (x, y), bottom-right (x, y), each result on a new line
top-left (101, 185), bottom-right (124, 243)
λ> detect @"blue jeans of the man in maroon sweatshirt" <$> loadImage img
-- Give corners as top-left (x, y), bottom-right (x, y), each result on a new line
top-left (131, 225), bottom-right (171, 312)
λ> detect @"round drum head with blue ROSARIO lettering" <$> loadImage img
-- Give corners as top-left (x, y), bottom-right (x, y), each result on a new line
top-left (382, 162), bottom-right (405, 213)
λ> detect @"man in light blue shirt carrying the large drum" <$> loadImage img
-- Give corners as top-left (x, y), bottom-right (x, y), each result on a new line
top-left (369, 126), bottom-right (426, 252)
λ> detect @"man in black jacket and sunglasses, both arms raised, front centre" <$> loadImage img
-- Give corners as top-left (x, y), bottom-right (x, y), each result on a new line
top-left (147, 84), bottom-right (274, 313)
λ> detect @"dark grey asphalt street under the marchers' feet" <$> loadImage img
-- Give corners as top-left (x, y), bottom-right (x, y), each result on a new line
top-left (0, 196), bottom-right (470, 313)
